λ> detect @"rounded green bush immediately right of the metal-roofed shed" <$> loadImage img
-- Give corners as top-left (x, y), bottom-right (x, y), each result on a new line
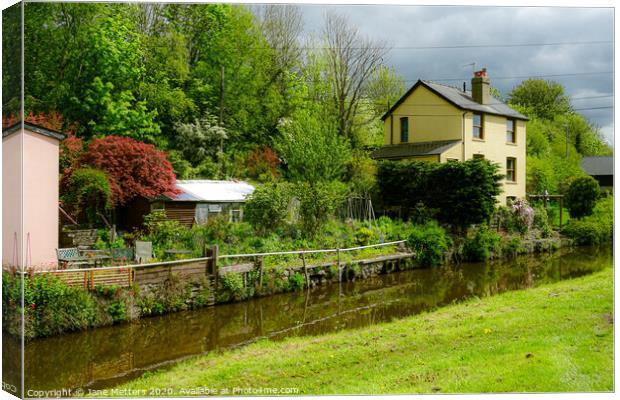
top-left (243, 183), bottom-right (292, 234)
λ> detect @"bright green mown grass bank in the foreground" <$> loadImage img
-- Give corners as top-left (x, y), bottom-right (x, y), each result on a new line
top-left (108, 269), bottom-right (613, 395)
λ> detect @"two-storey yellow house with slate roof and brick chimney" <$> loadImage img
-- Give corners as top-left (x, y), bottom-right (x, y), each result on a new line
top-left (373, 69), bottom-right (528, 204)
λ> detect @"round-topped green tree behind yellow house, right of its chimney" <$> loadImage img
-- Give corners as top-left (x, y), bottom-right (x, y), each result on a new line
top-left (508, 78), bottom-right (572, 120)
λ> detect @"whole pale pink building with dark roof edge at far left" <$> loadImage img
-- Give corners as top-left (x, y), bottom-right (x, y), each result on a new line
top-left (2, 123), bottom-right (63, 269)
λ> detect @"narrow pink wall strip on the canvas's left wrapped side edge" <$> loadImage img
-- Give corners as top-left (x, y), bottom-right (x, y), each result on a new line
top-left (2, 132), bottom-right (24, 266)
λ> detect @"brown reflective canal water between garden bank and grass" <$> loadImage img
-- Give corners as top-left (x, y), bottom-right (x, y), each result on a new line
top-left (3, 248), bottom-right (613, 390)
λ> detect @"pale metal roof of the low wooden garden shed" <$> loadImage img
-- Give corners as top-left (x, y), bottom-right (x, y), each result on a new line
top-left (166, 180), bottom-right (254, 203)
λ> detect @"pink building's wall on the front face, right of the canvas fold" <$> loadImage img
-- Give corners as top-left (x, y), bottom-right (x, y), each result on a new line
top-left (23, 130), bottom-right (59, 268)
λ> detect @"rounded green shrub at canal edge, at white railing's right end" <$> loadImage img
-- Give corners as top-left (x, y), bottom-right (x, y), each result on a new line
top-left (407, 221), bottom-right (452, 266)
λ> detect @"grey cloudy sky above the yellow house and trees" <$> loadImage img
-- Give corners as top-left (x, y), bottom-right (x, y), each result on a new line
top-left (299, 4), bottom-right (614, 144)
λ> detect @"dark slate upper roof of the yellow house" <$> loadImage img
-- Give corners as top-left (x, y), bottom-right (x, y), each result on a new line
top-left (381, 80), bottom-right (529, 121)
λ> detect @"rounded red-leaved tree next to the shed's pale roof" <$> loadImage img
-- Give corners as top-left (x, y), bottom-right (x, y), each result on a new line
top-left (81, 136), bottom-right (178, 206)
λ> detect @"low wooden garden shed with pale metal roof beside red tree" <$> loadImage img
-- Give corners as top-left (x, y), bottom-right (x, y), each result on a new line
top-left (124, 179), bottom-right (254, 228)
